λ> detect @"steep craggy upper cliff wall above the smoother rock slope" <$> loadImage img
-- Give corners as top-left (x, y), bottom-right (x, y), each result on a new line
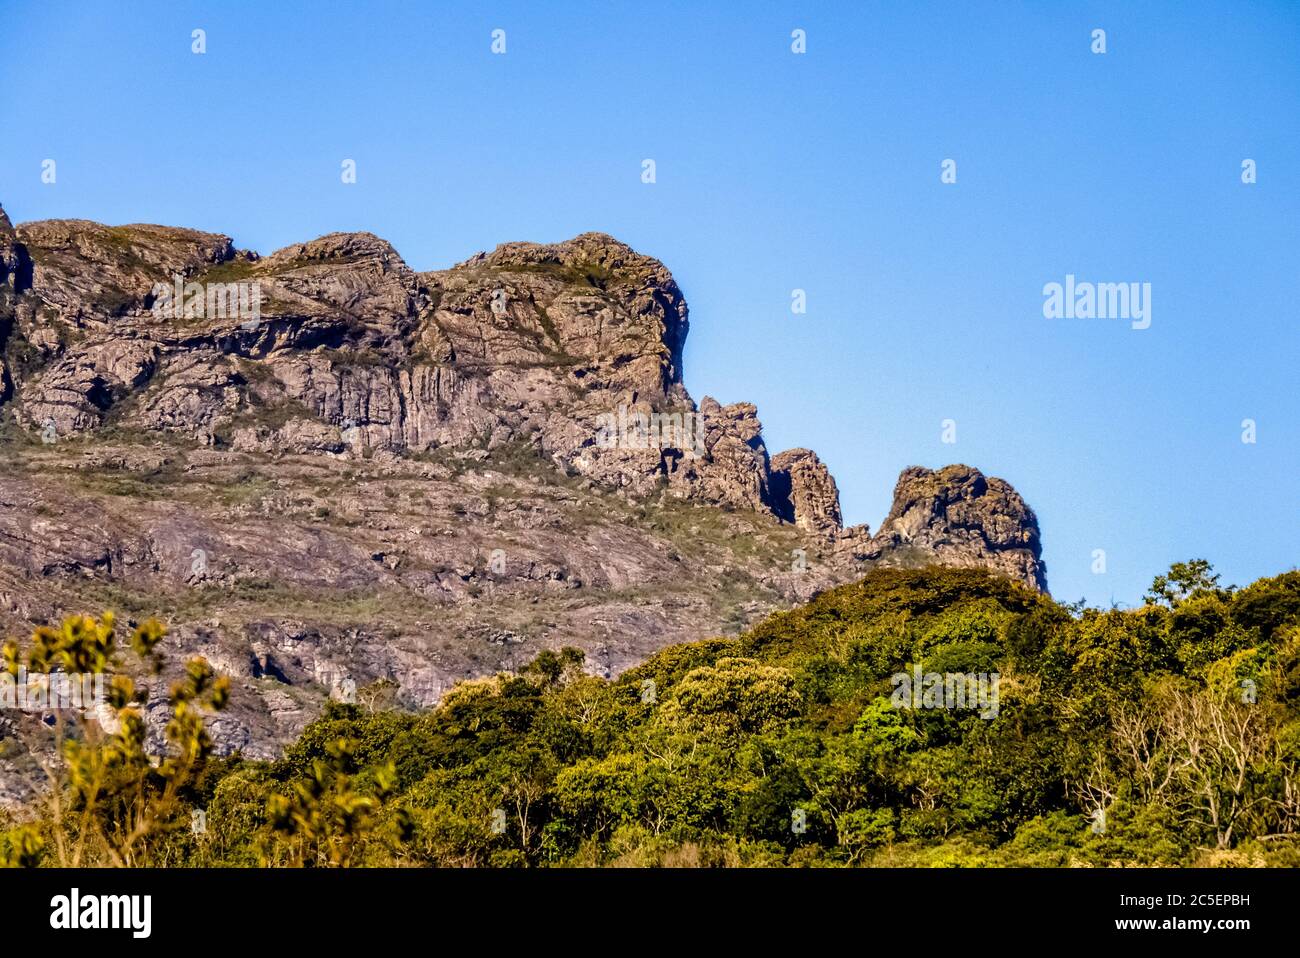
top-left (7, 221), bottom-right (767, 508)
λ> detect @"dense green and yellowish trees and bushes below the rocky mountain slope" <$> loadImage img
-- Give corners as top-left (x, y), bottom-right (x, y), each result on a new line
top-left (0, 562), bottom-right (1300, 866)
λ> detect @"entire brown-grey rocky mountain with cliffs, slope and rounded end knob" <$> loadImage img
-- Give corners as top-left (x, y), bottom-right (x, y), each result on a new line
top-left (0, 211), bottom-right (1045, 797)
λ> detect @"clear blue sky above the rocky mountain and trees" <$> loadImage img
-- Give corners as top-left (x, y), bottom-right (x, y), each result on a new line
top-left (0, 0), bottom-right (1300, 604)
